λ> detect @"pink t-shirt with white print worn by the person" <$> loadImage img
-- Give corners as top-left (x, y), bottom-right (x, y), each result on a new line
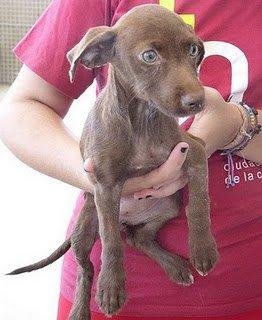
top-left (14, 0), bottom-right (262, 317)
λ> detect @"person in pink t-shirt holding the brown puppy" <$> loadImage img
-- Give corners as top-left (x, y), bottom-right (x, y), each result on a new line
top-left (0, 0), bottom-right (262, 320)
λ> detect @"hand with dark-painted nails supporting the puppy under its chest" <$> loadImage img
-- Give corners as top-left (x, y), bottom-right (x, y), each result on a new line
top-left (84, 142), bottom-right (188, 199)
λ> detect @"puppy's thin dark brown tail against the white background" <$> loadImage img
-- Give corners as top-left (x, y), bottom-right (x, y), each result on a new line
top-left (6, 238), bottom-right (71, 275)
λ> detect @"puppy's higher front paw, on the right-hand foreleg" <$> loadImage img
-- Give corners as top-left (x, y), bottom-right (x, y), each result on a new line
top-left (190, 235), bottom-right (219, 276)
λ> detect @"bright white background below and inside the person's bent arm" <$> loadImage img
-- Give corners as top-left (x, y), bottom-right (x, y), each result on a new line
top-left (0, 85), bottom-right (95, 320)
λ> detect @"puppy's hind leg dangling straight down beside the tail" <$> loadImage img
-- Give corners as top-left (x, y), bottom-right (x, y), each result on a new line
top-left (69, 194), bottom-right (98, 320)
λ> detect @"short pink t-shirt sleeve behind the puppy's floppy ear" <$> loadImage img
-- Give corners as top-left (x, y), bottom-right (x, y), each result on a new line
top-left (13, 0), bottom-right (106, 99)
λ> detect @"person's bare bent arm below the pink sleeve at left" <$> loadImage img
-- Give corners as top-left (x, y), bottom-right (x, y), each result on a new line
top-left (0, 66), bottom-right (91, 190)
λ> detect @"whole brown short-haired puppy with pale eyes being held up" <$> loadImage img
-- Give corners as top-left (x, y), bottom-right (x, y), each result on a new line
top-left (7, 5), bottom-right (218, 320)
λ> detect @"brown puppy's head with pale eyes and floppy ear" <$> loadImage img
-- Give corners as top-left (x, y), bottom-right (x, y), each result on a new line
top-left (67, 5), bottom-right (204, 117)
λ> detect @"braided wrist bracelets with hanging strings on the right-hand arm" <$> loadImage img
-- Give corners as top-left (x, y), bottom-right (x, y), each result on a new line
top-left (221, 102), bottom-right (262, 188)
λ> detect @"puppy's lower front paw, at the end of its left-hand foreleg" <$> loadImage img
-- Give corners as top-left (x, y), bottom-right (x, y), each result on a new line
top-left (96, 272), bottom-right (126, 316)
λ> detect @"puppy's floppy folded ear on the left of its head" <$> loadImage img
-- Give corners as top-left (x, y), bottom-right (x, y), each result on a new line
top-left (67, 26), bottom-right (116, 82)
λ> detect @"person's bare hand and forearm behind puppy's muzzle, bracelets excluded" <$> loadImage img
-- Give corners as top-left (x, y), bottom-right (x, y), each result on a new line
top-left (188, 87), bottom-right (262, 164)
